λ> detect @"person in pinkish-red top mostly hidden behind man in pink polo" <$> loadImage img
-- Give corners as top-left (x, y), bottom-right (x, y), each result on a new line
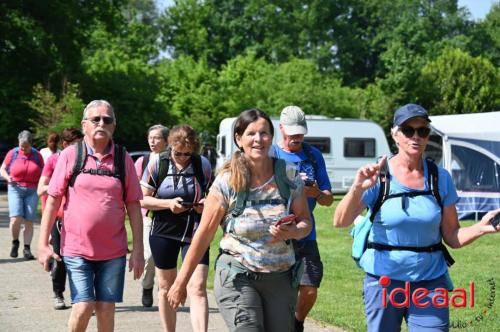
top-left (37, 128), bottom-right (83, 310)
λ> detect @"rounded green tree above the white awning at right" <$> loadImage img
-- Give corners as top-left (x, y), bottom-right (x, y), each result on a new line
top-left (417, 49), bottom-right (500, 114)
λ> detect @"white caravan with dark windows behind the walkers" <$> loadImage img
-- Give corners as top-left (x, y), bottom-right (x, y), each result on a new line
top-left (217, 115), bottom-right (390, 193)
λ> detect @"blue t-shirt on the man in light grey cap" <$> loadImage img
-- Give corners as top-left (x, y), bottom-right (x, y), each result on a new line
top-left (270, 144), bottom-right (332, 241)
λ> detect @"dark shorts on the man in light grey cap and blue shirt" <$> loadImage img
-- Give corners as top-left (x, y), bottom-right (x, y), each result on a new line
top-left (297, 240), bottom-right (323, 288)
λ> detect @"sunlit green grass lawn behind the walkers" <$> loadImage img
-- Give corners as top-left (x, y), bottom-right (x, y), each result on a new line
top-left (127, 200), bottom-right (500, 331)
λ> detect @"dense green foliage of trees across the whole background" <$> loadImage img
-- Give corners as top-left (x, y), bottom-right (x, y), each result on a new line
top-left (0, 0), bottom-right (500, 149)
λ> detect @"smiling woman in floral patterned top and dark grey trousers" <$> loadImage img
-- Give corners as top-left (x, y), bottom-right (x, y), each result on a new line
top-left (168, 109), bottom-right (311, 332)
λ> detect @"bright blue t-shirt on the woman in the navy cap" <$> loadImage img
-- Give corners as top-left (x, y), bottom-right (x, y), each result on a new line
top-left (360, 162), bottom-right (458, 281)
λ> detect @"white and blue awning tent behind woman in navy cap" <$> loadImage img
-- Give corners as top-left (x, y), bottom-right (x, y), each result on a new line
top-left (426, 112), bottom-right (500, 220)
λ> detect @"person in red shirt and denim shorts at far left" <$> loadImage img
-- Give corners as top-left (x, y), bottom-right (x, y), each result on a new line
top-left (0, 130), bottom-right (43, 260)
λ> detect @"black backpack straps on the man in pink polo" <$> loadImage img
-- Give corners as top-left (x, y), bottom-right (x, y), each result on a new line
top-left (68, 140), bottom-right (127, 196)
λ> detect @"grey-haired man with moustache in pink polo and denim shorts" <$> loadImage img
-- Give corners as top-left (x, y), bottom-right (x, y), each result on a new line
top-left (38, 100), bottom-right (144, 331)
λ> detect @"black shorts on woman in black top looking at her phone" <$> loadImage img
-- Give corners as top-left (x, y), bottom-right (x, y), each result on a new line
top-left (149, 235), bottom-right (210, 270)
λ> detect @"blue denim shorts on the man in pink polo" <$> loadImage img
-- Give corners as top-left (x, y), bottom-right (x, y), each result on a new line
top-left (63, 256), bottom-right (126, 303)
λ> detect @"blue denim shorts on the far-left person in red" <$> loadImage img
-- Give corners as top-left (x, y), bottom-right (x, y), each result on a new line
top-left (7, 184), bottom-right (38, 221)
